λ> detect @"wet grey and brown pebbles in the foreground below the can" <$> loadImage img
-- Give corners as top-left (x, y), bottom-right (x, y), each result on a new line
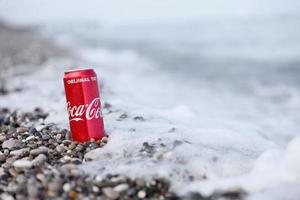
top-left (0, 108), bottom-right (238, 200)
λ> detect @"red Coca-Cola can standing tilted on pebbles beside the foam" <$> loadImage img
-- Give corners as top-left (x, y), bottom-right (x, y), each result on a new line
top-left (64, 69), bottom-right (105, 142)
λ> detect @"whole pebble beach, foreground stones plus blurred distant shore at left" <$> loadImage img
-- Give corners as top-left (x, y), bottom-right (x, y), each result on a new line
top-left (0, 21), bottom-right (246, 200)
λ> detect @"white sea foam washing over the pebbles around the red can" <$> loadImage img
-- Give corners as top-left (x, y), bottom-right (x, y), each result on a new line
top-left (0, 43), bottom-right (300, 199)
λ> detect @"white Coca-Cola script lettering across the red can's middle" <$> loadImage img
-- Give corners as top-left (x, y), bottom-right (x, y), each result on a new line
top-left (67, 98), bottom-right (102, 122)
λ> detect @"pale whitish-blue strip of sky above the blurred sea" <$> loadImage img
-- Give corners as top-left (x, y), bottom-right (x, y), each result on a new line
top-left (0, 0), bottom-right (300, 24)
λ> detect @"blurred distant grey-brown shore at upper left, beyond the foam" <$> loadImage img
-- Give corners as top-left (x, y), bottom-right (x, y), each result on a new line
top-left (0, 20), bottom-right (70, 80)
